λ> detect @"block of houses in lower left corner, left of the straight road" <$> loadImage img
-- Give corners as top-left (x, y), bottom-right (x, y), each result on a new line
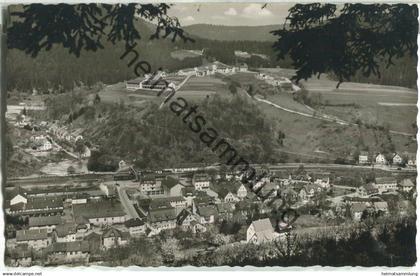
top-left (5, 183), bottom-right (130, 265)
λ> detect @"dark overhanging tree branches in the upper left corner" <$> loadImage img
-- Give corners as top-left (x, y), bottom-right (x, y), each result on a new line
top-left (8, 3), bottom-right (192, 57)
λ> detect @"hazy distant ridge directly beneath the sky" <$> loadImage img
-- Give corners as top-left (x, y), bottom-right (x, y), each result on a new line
top-left (183, 24), bottom-right (283, 41)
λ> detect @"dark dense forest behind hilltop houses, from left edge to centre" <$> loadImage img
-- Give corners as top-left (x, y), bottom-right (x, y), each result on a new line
top-left (6, 20), bottom-right (288, 93)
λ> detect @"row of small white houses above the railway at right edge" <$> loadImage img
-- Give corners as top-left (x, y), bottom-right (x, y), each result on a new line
top-left (359, 151), bottom-right (417, 167)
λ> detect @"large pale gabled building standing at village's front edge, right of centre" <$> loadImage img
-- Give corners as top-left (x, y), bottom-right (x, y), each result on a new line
top-left (246, 218), bottom-right (280, 244)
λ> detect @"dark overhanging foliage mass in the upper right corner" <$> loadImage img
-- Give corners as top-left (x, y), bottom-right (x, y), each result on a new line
top-left (272, 3), bottom-right (418, 88)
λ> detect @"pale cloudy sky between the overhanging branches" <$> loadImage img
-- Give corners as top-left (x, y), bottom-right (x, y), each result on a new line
top-left (168, 3), bottom-right (293, 26)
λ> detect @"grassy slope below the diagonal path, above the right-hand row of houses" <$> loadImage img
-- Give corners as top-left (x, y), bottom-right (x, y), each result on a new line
top-left (253, 97), bottom-right (417, 162)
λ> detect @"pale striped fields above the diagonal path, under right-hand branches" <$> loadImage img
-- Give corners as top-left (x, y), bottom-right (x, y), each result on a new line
top-left (253, 68), bottom-right (417, 135)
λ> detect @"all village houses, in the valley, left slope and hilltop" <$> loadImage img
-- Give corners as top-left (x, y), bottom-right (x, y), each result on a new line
top-left (5, 58), bottom-right (416, 266)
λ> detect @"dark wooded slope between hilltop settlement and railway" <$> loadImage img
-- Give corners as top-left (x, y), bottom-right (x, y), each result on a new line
top-left (41, 92), bottom-right (284, 170)
